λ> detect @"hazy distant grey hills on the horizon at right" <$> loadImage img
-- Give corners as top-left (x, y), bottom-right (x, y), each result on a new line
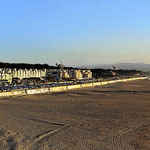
top-left (81, 63), bottom-right (150, 71)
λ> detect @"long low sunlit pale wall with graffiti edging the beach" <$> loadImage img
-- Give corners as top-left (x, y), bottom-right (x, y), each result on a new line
top-left (0, 77), bottom-right (148, 97)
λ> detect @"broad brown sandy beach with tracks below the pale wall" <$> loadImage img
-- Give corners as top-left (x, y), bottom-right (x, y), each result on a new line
top-left (0, 80), bottom-right (150, 150)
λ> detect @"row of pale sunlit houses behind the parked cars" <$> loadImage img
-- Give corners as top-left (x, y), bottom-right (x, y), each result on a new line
top-left (0, 68), bottom-right (92, 83)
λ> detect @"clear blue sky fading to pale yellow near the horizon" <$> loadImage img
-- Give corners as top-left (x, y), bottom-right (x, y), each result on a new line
top-left (0, 0), bottom-right (150, 66)
